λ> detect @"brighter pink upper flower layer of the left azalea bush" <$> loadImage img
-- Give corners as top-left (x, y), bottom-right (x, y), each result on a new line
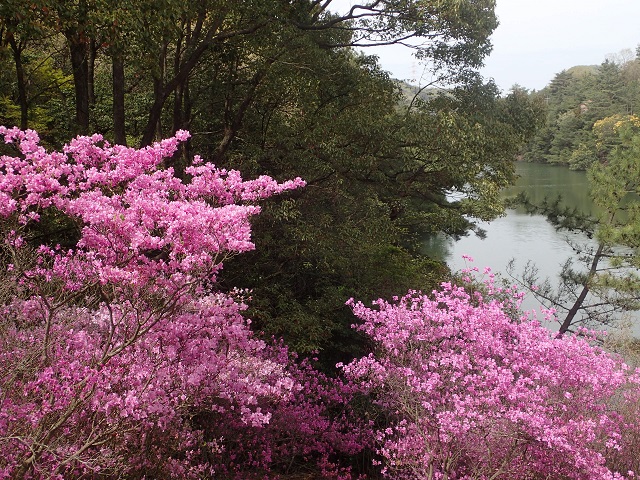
top-left (0, 127), bottom-right (304, 291)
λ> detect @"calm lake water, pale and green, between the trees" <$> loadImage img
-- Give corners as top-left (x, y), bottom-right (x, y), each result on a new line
top-left (423, 162), bottom-right (628, 326)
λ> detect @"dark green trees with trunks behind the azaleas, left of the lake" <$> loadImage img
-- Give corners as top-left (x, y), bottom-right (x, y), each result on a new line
top-left (0, 0), bottom-right (540, 362)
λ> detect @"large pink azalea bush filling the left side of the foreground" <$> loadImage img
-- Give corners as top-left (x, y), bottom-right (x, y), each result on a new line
top-left (0, 127), bottom-right (368, 479)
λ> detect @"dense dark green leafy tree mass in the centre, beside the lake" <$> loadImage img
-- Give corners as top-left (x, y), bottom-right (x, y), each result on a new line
top-left (214, 63), bottom-right (540, 360)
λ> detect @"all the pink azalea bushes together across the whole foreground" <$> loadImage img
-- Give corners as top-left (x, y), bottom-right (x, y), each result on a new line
top-left (0, 127), bottom-right (640, 480)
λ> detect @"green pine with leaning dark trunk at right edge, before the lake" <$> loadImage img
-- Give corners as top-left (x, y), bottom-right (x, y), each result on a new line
top-left (520, 115), bottom-right (640, 333)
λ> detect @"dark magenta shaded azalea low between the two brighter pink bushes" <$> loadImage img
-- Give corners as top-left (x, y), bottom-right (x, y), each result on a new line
top-left (202, 349), bottom-right (374, 480)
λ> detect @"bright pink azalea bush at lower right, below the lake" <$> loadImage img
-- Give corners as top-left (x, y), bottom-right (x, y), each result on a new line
top-left (342, 284), bottom-right (640, 479)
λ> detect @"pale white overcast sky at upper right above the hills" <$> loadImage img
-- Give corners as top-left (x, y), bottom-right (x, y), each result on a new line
top-left (332, 0), bottom-right (640, 91)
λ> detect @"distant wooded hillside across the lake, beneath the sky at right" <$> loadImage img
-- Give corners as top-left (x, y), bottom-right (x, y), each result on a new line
top-left (524, 45), bottom-right (640, 170)
